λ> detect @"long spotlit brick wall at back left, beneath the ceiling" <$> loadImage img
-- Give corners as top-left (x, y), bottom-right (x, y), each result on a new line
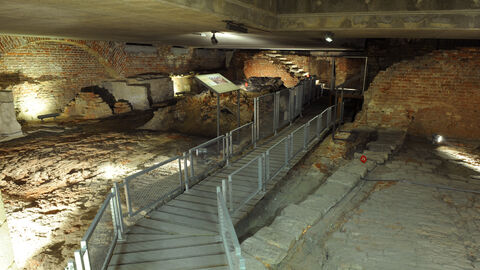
top-left (0, 35), bottom-right (225, 120)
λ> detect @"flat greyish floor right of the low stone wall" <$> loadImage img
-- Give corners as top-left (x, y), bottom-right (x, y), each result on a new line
top-left (280, 137), bottom-right (480, 270)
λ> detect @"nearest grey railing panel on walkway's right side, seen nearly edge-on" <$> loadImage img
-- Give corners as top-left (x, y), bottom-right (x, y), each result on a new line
top-left (217, 186), bottom-right (246, 270)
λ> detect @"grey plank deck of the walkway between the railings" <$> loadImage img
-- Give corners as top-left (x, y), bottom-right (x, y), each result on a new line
top-left (108, 108), bottom-right (326, 270)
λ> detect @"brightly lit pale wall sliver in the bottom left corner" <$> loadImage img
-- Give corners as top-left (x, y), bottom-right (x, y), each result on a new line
top-left (0, 193), bottom-right (16, 270)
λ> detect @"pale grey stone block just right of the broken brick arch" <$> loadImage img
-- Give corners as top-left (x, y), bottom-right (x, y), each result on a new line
top-left (102, 81), bottom-right (150, 110)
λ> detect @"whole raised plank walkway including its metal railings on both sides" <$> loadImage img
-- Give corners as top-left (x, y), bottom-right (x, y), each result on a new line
top-left (67, 78), bottom-right (343, 270)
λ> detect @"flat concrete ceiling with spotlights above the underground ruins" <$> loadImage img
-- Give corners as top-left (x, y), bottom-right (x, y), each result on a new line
top-left (0, 0), bottom-right (480, 51)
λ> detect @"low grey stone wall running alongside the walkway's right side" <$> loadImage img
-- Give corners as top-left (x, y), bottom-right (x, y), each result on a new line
top-left (241, 130), bottom-right (405, 270)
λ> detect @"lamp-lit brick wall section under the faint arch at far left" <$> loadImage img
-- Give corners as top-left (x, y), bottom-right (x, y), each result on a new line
top-left (0, 42), bottom-right (108, 120)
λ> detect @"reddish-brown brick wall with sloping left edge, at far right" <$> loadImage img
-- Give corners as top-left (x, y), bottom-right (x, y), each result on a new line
top-left (356, 48), bottom-right (480, 138)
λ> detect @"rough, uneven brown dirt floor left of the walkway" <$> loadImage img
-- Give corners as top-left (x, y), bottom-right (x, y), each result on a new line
top-left (0, 112), bottom-right (206, 270)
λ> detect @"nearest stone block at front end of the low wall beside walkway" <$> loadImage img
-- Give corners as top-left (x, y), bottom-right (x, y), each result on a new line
top-left (241, 237), bottom-right (287, 264)
